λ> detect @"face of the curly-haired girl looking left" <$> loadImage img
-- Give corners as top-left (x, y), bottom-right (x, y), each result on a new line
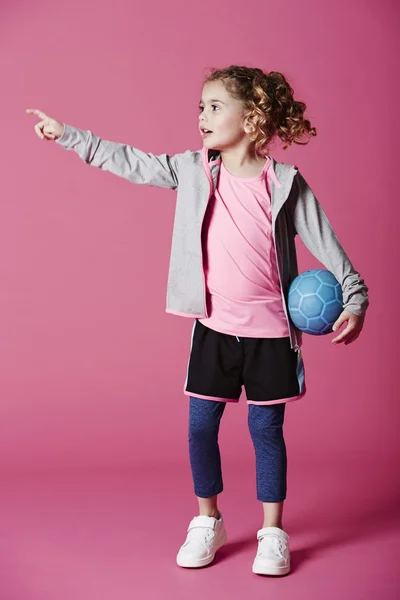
top-left (199, 81), bottom-right (248, 151)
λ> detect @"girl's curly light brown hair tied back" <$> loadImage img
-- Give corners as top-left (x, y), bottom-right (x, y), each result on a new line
top-left (203, 65), bottom-right (317, 156)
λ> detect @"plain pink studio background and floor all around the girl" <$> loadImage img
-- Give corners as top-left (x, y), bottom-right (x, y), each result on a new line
top-left (0, 0), bottom-right (399, 600)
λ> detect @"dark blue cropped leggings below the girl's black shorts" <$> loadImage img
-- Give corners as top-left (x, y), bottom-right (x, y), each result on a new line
top-left (189, 396), bottom-right (287, 502)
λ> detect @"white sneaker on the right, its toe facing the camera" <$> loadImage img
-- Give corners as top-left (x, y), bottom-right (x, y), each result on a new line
top-left (252, 527), bottom-right (290, 575)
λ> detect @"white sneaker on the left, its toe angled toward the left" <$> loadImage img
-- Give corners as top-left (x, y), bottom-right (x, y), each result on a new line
top-left (176, 513), bottom-right (226, 567)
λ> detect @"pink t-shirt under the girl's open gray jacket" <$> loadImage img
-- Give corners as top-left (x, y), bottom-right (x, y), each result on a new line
top-left (198, 158), bottom-right (289, 338)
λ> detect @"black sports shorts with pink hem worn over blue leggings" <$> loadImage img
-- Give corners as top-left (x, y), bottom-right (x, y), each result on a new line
top-left (184, 319), bottom-right (306, 404)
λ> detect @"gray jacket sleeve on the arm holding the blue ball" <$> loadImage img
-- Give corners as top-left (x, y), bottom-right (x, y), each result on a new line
top-left (290, 171), bottom-right (369, 316)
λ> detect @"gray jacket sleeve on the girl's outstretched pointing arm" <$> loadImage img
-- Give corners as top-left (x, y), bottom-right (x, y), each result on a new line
top-left (56, 124), bottom-right (181, 189)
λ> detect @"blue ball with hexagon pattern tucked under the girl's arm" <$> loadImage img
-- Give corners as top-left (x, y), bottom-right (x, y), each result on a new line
top-left (288, 269), bottom-right (343, 335)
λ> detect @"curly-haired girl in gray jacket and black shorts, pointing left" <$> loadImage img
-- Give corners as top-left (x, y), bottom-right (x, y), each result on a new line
top-left (27, 65), bottom-right (369, 575)
